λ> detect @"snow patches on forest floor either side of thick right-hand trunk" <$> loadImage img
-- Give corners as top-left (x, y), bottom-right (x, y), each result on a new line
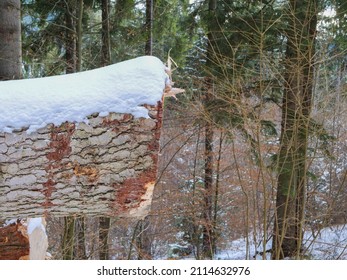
top-left (215, 224), bottom-right (347, 260)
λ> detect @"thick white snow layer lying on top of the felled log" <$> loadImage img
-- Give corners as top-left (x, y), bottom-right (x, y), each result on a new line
top-left (0, 56), bottom-right (169, 133)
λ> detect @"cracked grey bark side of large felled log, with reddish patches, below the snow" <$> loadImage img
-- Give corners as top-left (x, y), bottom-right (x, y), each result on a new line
top-left (0, 102), bottom-right (162, 219)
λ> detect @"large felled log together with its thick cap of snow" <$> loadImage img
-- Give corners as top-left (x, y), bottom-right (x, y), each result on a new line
top-left (0, 57), bottom-right (168, 218)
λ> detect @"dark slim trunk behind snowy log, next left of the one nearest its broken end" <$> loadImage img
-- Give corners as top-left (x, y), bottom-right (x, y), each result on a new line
top-left (101, 0), bottom-right (111, 66)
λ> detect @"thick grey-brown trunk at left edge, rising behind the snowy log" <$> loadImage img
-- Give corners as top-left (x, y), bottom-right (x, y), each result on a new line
top-left (0, 0), bottom-right (22, 81)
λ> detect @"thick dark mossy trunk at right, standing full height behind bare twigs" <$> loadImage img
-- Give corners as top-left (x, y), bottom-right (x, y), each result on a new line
top-left (272, 0), bottom-right (317, 259)
